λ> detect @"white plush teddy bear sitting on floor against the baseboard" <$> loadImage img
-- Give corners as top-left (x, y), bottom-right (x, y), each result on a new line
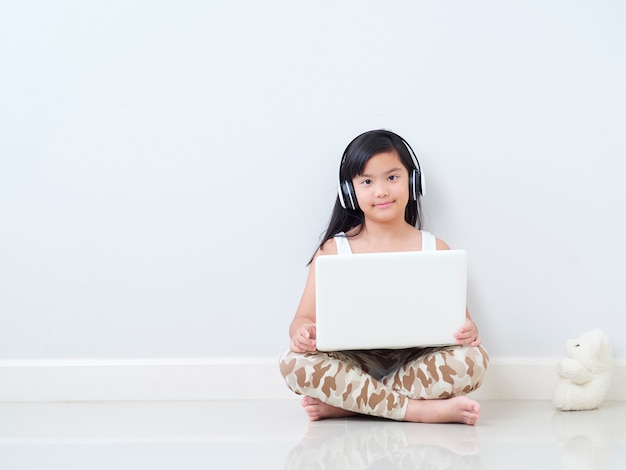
top-left (553, 329), bottom-right (613, 411)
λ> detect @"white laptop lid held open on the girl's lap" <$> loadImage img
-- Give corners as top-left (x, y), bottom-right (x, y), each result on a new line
top-left (315, 250), bottom-right (467, 351)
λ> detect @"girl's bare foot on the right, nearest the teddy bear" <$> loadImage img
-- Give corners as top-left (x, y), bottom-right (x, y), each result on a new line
top-left (404, 396), bottom-right (480, 426)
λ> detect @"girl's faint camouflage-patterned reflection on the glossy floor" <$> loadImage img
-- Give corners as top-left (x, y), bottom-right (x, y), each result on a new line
top-left (285, 418), bottom-right (483, 470)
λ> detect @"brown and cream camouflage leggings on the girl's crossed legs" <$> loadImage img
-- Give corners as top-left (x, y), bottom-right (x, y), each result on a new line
top-left (280, 346), bottom-right (489, 421)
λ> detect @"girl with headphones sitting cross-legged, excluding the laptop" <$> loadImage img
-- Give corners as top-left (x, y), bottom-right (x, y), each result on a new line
top-left (280, 130), bottom-right (489, 425)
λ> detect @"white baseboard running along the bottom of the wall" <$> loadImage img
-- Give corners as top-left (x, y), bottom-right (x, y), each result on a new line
top-left (0, 357), bottom-right (626, 402)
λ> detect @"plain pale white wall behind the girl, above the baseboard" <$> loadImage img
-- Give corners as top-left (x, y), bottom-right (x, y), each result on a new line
top-left (0, 0), bottom-right (626, 359)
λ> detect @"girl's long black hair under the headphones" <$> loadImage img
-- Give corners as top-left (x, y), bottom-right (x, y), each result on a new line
top-left (309, 129), bottom-right (422, 264)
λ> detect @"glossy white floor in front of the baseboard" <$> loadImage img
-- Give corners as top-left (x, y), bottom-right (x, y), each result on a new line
top-left (0, 400), bottom-right (626, 470)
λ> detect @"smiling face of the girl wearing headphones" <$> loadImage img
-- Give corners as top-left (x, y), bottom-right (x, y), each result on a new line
top-left (352, 151), bottom-right (409, 221)
